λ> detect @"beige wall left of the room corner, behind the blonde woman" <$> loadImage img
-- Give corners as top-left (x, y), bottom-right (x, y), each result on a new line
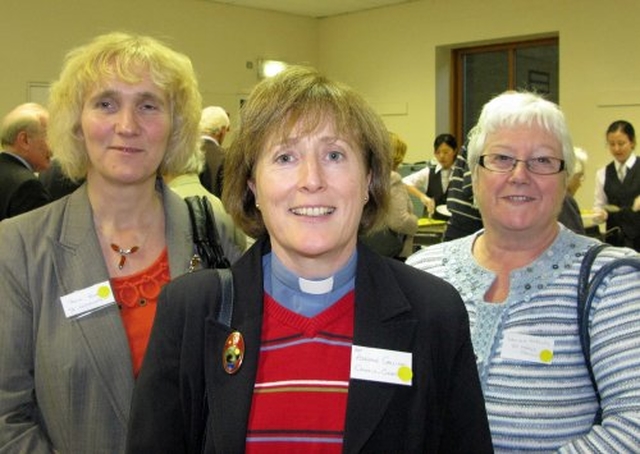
top-left (0, 0), bottom-right (318, 134)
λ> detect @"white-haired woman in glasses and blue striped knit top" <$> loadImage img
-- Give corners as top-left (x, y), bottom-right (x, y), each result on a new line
top-left (407, 92), bottom-right (640, 453)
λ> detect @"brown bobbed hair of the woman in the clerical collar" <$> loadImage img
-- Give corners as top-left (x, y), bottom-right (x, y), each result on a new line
top-left (222, 66), bottom-right (391, 238)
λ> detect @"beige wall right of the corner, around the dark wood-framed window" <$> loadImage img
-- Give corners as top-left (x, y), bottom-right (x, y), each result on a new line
top-left (319, 0), bottom-right (640, 208)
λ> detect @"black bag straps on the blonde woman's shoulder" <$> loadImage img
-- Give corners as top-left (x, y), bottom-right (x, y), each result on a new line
top-left (185, 196), bottom-right (230, 268)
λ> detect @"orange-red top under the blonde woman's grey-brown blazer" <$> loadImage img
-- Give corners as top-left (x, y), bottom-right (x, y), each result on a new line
top-left (111, 248), bottom-right (170, 377)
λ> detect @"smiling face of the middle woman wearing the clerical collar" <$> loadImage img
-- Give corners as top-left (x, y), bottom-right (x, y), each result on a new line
top-left (249, 117), bottom-right (370, 278)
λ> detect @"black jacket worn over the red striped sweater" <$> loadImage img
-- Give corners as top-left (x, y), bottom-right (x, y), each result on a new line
top-left (128, 239), bottom-right (492, 454)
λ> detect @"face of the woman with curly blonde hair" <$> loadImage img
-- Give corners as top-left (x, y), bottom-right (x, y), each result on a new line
top-left (80, 76), bottom-right (171, 185)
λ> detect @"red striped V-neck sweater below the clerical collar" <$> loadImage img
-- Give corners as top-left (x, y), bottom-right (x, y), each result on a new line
top-left (246, 291), bottom-right (354, 454)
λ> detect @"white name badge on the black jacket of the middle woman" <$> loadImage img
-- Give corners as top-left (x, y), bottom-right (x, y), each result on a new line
top-left (351, 345), bottom-right (413, 386)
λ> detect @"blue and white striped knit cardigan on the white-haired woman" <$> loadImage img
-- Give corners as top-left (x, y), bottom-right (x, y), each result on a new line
top-left (407, 228), bottom-right (640, 453)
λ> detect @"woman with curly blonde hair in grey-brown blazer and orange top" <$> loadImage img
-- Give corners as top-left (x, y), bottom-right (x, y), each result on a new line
top-left (0, 32), bottom-right (201, 454)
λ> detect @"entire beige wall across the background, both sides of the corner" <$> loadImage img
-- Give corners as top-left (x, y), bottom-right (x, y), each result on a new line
top-left (0, 0), bottom-right (640, 207)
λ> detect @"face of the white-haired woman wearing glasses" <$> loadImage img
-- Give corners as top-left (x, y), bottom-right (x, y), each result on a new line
top-left (473, 122), bottom-right (566, 238)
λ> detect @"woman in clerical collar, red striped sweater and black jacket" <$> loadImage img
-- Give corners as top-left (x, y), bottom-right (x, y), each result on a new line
top-left (128, 66), bottom-right (491, 454)
